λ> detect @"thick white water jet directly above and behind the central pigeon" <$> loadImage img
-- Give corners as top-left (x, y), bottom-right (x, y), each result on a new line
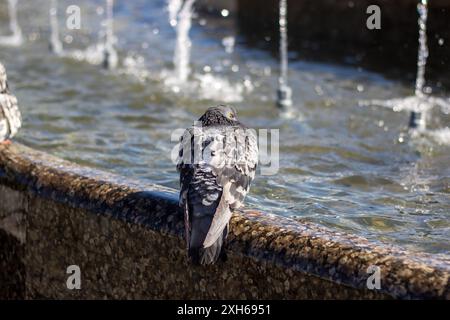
top-left (169, 0), bottom-right (195, 83)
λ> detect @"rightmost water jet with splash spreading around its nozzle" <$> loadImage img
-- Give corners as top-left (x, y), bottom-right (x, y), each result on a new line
top-left (359, 0), bottom-right (450, 132)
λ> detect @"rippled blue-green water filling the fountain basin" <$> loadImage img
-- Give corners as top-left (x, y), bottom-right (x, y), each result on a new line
top-left (0, 0), bottom-right (450, 253)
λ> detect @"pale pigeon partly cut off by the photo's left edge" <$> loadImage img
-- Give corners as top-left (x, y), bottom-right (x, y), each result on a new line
top-left (0, 63), bottom-right (22, 144)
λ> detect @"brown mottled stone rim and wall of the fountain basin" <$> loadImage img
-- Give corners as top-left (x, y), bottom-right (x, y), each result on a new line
top-left (0, 144), bottom-right (450, 299)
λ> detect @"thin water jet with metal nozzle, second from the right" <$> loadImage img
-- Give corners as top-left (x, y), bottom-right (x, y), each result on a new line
top-left (277, 0), bottom-right (292, 108)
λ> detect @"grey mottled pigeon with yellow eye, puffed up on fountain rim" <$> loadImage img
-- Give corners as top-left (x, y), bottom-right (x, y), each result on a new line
top-left (177, 105), bottom-right (258, 265)
